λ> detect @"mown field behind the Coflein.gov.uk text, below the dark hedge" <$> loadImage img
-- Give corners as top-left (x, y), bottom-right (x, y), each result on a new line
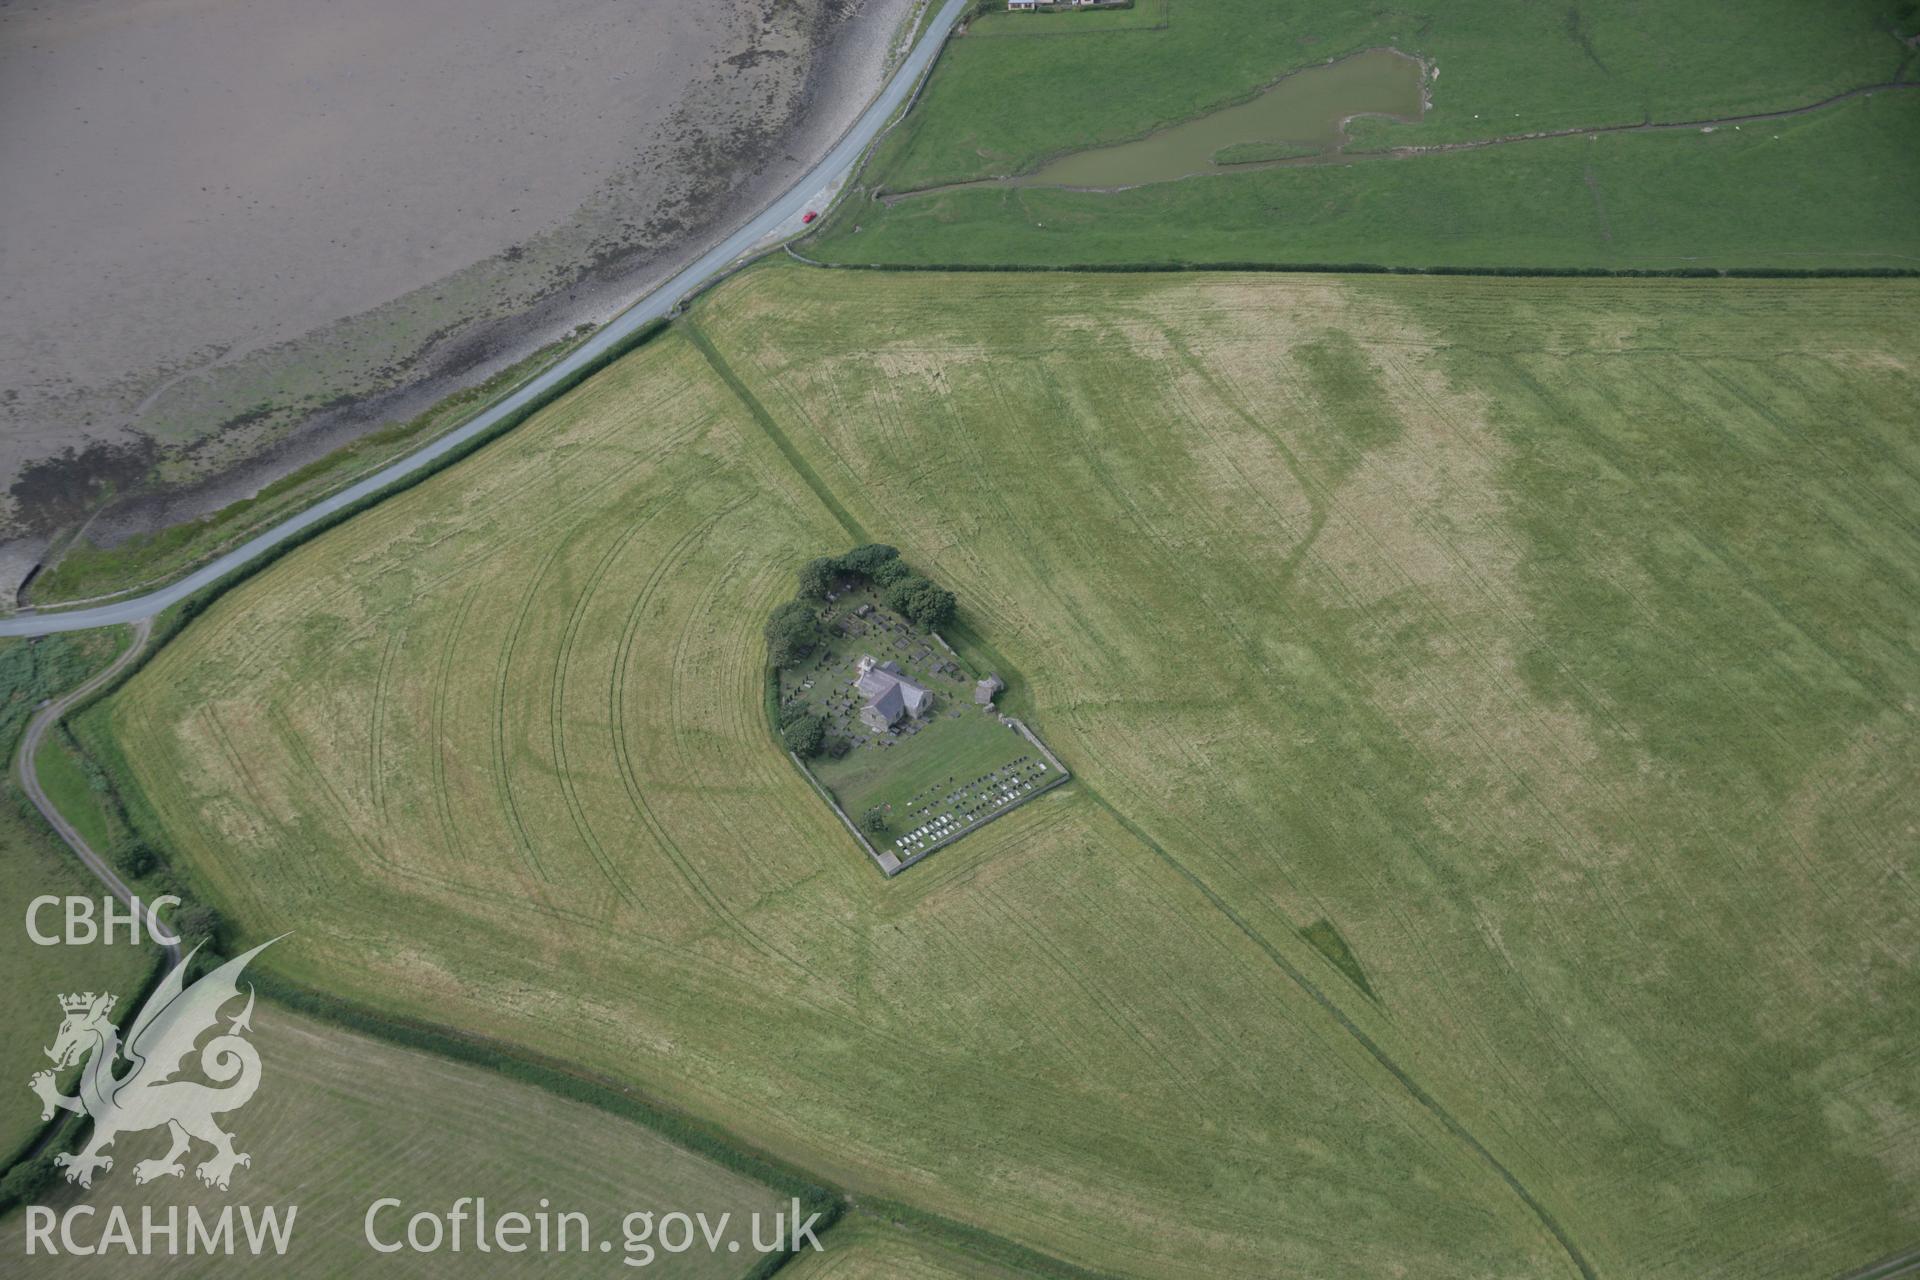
top-left (0, 1002), bottom-right (785, 1278)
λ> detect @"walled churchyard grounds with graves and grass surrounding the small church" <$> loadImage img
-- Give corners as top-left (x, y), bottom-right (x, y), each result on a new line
top-left (780, 585), bottom-right (1068, 871)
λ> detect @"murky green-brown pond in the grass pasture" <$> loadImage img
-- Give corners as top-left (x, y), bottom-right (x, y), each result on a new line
top-left (1012, 48), bottom-right (1425, 186)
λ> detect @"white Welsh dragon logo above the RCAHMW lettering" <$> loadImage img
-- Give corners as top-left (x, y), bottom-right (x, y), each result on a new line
top-left (27, 938), bottom-right (278, 1192)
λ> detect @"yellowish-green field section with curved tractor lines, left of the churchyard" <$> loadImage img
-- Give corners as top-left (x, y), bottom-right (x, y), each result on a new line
top-left (90, 322), bottom-right (1561, 1276)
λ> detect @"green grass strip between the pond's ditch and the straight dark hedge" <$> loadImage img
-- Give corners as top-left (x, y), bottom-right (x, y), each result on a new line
top-left (817, 90), bottom-right (1920, 271)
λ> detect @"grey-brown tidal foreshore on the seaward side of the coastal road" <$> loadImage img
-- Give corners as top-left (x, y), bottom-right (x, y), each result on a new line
top-left (0, 0), bottom-right (914, 603)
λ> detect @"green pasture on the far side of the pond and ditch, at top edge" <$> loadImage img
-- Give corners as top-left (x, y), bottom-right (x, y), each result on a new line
top-left (877, 0), bottom-right (1920, 190)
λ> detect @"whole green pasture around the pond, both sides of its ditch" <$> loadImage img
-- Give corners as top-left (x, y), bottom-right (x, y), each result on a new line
top-left (804, 0), bottom-right (1920, 271)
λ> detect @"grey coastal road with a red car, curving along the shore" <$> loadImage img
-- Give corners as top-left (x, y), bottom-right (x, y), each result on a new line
top-left (0, 0), bottom-right (968, 635)
